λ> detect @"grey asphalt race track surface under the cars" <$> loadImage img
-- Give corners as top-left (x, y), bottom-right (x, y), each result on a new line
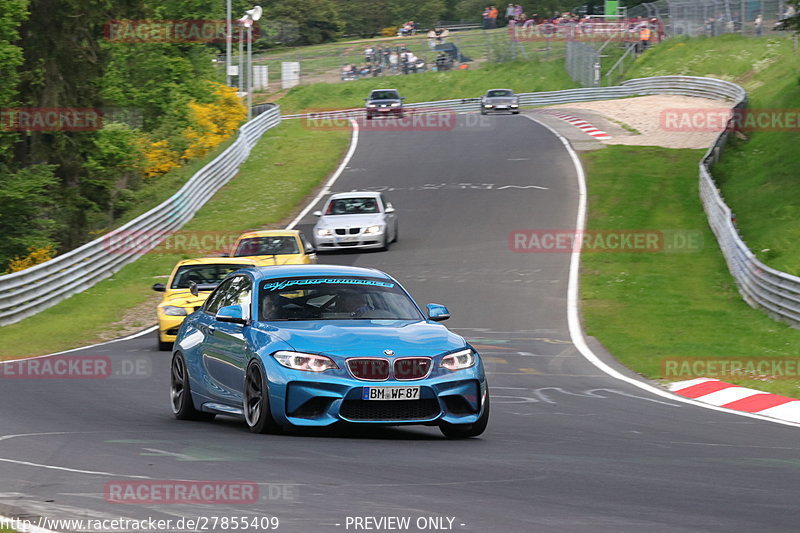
top-left (0, 115), bottom-right (800, 533)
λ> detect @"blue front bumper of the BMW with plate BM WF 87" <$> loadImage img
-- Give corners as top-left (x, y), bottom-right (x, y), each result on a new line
top-left (267, 363), bottom-right (487, 427)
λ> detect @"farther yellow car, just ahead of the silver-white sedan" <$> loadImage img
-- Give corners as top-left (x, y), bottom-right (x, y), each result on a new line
top-left (231, 230), bottom-right (317, 266)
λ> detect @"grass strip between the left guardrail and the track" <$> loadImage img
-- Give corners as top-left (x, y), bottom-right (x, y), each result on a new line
top-left (0, 121), bottom-right (350, 359)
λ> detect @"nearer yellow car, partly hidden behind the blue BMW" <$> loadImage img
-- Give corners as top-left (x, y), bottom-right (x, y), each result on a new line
top-left (153, 257), bottom-right (260, 351)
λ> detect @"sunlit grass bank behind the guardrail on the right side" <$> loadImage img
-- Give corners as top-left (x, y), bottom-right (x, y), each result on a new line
top-left (631, 34), bottom-right (800, 275)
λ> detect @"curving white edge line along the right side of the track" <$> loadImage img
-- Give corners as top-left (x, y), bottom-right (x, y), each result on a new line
top-left (523, 114), bottom-right (800, 427)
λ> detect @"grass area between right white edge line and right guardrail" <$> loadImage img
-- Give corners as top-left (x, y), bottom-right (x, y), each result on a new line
top-left (581, 146), bottom-right (800, 397)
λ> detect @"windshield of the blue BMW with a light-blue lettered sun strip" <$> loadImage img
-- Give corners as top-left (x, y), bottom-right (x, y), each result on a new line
top-left (259, 277), bottom-right (424, 321)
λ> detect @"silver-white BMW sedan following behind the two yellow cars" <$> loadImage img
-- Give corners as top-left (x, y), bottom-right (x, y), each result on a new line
top-left (313, 192), bottom-right (397, 252)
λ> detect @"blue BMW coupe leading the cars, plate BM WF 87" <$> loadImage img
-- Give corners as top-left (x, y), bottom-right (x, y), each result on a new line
top-left (170, 265), bottom-right (489, 438)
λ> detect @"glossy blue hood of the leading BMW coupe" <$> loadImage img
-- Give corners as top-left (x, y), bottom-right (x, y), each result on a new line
top-left (273, 320), bottom-right (466, 357)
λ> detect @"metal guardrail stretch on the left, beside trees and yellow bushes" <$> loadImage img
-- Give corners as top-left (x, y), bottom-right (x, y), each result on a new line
top-left (0, 105), bottom-right (281, 325)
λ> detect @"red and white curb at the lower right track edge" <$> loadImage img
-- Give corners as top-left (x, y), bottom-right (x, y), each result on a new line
top-left (669, 378), bottom-right (800, 422)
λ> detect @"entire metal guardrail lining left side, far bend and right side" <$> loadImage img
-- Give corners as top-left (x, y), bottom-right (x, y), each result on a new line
top-left (0, 76), bottom-right (800, 326)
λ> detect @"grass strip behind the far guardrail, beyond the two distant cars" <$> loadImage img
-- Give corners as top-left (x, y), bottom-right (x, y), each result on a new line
top-left (277, 60), bottom-right (577, 113)
